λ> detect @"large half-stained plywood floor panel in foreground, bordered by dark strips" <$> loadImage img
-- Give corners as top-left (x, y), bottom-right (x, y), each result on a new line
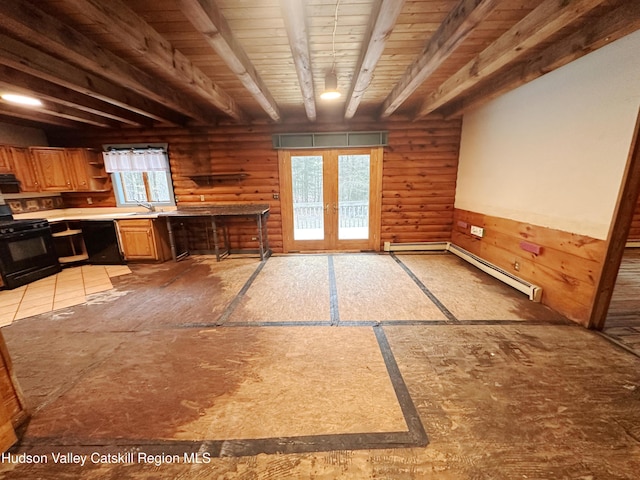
top-left (28, 327), bottom-right (408, 445)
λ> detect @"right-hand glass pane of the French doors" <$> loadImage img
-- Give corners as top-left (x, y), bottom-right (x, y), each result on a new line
top-left (338, 155), bottom-right (370, 240)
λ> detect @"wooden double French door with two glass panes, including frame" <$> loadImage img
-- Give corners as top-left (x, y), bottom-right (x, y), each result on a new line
top-left (279, 148), bottom-right (382, 252)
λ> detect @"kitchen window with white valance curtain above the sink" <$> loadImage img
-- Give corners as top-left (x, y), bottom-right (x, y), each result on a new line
top-left (102, 148), bottom-right (175, 206)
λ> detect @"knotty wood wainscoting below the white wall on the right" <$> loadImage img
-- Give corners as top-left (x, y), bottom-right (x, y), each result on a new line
top-left (451, 209), bottom-right (606, 326)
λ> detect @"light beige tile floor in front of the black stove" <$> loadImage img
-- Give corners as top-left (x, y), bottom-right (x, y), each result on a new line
top-left (0, 265), bottom-right (131, 327)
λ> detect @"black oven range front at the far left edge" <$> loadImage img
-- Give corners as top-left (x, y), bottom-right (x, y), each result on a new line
top-left (0, 226), bottom-right (60, 288)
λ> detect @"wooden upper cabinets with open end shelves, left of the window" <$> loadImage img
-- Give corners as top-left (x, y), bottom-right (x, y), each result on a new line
top-left (29, 147), bottom-right (110, 192)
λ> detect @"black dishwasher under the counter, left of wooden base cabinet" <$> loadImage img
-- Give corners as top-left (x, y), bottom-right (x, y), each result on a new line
top-left (81, 220), bottom-right (125, 265)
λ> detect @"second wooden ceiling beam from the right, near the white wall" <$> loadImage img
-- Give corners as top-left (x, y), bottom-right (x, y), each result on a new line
top-left (416, 0), bottom-right (608, 118)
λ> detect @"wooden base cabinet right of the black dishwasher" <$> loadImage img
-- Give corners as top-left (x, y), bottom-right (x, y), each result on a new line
top-left (116, 218), bottom-right (171, 262)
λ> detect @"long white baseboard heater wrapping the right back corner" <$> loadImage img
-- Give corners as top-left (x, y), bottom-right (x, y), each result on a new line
top-left (384, 242), bottom-right (542, 302)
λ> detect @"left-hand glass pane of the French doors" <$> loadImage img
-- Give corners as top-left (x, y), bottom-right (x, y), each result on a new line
top-left (291, 155), bottom-right (324, 240)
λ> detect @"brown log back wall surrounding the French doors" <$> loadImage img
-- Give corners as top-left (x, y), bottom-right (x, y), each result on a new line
top-left (50, 118), bottom-right (461, 252)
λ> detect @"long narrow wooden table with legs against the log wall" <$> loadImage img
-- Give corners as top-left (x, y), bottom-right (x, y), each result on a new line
top-left (158, 204), bottom-right (271, 262)
